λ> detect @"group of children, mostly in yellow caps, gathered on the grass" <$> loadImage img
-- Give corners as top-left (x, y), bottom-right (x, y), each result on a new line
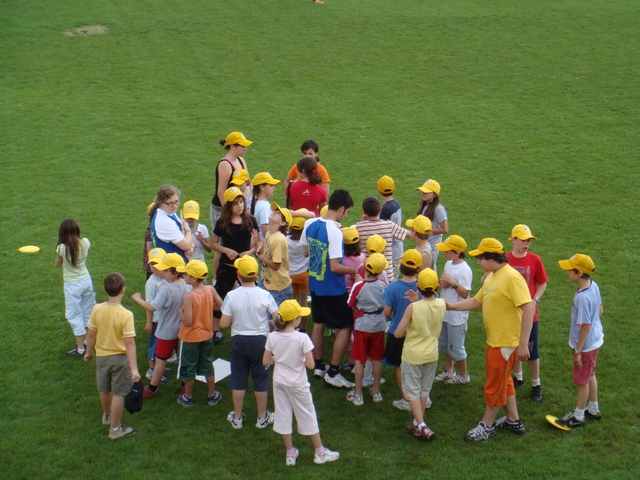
top-left (56, 150), bottom-right (603, 454)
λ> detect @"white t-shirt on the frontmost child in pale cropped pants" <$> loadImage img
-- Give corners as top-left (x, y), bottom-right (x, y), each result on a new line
top-left (264, 332), bottom-right (313, 387)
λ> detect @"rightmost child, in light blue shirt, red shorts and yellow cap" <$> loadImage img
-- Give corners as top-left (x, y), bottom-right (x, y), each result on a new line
top-left (556, 253), bottom-right (604, 427)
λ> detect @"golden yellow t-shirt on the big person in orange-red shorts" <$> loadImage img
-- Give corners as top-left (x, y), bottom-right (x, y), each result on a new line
top-left (474, 265), bottom-right (531, 348)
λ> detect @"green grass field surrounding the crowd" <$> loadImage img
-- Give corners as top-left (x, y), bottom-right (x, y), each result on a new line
top-left (0, 0), bottom-right (640, 479)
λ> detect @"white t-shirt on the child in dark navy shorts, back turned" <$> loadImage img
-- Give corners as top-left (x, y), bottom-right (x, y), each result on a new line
top-left (221, 287), bottom-right (278, 337)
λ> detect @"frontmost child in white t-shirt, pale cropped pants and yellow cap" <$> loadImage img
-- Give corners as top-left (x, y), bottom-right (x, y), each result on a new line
top-left (262, 300), bottom-right (340, 466)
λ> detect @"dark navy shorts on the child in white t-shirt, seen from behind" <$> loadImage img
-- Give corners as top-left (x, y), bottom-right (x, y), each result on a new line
top-left (229, 335), bottom-right (271, 392)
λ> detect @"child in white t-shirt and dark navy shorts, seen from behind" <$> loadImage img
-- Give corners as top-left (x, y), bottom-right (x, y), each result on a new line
top-left (220, 255), bottom-right (278, 429)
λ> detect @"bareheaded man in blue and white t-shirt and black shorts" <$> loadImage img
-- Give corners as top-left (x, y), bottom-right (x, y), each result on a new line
top-left (300, 189), bottom-right (360, 388)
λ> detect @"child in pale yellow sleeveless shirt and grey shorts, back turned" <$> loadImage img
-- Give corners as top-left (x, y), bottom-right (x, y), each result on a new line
top-left (394, 268), bottom-right (447, 441)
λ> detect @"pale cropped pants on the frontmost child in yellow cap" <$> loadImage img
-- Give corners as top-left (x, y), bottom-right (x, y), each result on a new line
top-left (273, 382), bottom-right (320, 436)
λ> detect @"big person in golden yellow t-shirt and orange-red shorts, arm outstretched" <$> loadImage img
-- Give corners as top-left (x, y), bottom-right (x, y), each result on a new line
top-left (447, 238), bottom-right (535, 441)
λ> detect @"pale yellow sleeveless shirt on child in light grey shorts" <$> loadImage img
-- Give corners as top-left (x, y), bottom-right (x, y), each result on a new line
top-left (402, 298), bottom-right (447, 365)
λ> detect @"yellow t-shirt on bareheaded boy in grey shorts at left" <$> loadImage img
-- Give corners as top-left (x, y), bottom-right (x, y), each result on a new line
top-left (87, 302), bottom-right (136, 357)
